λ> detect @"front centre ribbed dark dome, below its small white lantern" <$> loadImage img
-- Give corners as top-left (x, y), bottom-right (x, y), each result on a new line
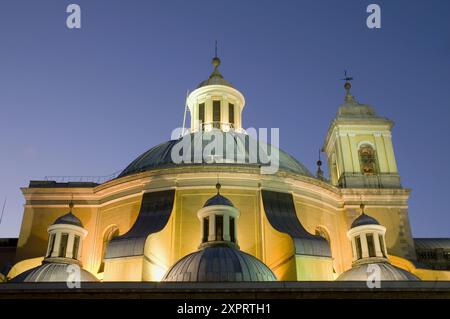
top-left (163, 244), bottom-right (277, 282)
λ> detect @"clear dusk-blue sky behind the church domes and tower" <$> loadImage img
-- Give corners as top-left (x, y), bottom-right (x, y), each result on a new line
top-left (0, 0), bottom-right (450, 237)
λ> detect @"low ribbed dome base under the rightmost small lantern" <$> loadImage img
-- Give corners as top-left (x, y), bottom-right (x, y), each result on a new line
top-left (336, 262), bottom-right (420, 281)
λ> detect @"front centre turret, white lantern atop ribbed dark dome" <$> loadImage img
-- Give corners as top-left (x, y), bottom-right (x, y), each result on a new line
top-left (163, 183), bottom-right (277, 282)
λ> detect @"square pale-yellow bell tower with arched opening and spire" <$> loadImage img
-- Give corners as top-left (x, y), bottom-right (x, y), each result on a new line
top-left (322, 79), bottom-right (401, 188)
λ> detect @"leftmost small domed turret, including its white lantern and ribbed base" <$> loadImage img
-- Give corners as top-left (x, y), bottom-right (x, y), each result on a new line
top-left (12, 202), bottom-right (97, 282)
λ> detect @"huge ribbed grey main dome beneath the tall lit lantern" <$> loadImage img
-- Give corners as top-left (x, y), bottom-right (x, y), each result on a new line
top-left (118, 130), bottom-right (312, 177)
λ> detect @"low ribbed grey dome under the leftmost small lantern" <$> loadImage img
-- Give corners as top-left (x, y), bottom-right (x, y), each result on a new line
top-left (12, 263), bottom-right (98, 282)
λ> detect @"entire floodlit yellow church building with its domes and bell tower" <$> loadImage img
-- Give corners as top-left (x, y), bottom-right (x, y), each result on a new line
top-left (3, 57), bottom-right (450, 282)
